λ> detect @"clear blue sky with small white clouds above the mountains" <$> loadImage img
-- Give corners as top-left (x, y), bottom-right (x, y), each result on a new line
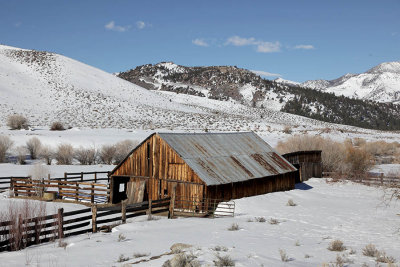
top-left (0, 0), bottom-right (400, 82)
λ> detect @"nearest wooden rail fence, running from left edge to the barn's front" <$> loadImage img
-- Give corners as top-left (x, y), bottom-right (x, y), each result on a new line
top-left (0, 198), bottom-right (171, 251)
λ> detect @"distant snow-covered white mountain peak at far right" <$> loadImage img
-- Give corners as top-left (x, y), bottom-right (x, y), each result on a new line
top-left (301, 61), bottom-right (400, 104)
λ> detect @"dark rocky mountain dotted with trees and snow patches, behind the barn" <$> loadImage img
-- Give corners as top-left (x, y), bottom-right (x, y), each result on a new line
top-left (118, 62), bottom-right (400, 130)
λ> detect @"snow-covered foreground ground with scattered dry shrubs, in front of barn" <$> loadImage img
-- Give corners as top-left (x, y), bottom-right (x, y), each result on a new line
top-left (0, 178), bottom-right (400, 266)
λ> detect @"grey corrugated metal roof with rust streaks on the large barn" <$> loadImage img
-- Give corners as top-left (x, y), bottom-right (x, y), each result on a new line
top-left (159, 132), bottom-right (296, 185)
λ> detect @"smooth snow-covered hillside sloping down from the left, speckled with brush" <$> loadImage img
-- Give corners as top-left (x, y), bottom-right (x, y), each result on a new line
top-left (0, 45), bottom-right (337, 131)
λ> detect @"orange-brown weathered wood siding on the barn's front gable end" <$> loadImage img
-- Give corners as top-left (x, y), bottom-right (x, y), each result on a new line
top-left (113, 134), bottom-right (205, 200)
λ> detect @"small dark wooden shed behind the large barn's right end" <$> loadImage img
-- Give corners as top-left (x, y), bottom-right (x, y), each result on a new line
top-left (282, 150), bottom-right (322, 183)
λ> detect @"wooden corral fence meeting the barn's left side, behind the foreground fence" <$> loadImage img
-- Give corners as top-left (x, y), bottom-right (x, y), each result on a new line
top-left (11, 178), bottom-right (110, 203)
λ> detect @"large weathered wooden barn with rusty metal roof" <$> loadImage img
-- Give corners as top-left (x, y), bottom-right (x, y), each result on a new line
top-left (110, 132), bottom-right (297, 206)
